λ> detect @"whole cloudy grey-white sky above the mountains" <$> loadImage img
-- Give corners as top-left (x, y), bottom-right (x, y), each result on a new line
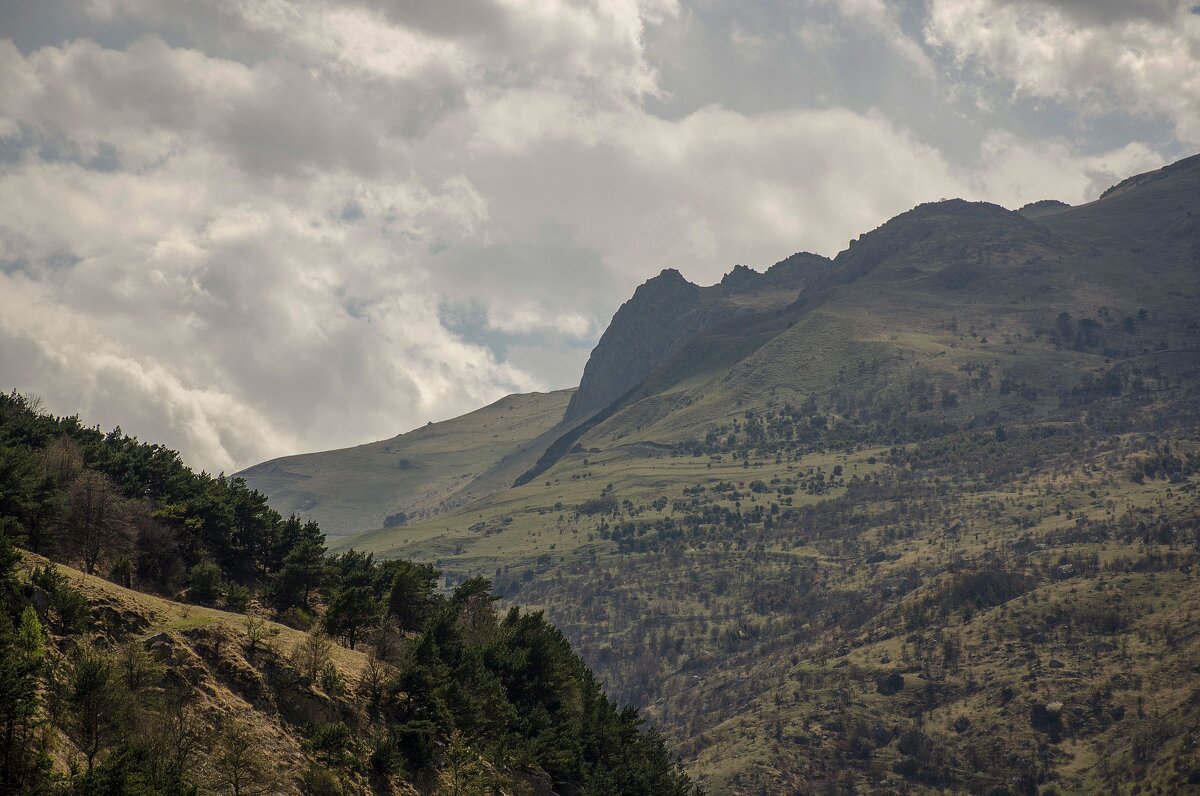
top-left (0, 0), bottom-right (1200, 472)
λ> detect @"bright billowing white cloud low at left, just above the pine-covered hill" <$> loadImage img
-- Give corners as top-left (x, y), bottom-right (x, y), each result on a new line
top-left (0, 141), bottom-right (538, 469)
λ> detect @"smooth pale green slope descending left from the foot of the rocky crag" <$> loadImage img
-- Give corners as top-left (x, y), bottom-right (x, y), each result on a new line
top-left (239, 390), bottom-right (571, 538)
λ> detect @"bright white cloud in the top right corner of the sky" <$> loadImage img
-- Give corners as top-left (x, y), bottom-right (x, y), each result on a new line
top-left (925, 0), bottom-right (1200, 144)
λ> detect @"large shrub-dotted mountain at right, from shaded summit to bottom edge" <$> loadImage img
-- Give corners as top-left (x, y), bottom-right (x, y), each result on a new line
top-left (333, 157), bottom-right (1200, 795)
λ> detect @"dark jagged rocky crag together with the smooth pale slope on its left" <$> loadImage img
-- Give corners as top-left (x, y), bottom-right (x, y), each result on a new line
top-left (236, 252), bottom-right (829, 538)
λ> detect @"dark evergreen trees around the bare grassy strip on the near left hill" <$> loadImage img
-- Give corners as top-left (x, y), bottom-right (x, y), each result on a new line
top-left (0, 394), bottom-right (692, 795)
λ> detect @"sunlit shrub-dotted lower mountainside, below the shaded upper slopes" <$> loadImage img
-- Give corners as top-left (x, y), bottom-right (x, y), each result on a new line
top-left (338, 417), bottom-right (1200, 792)
